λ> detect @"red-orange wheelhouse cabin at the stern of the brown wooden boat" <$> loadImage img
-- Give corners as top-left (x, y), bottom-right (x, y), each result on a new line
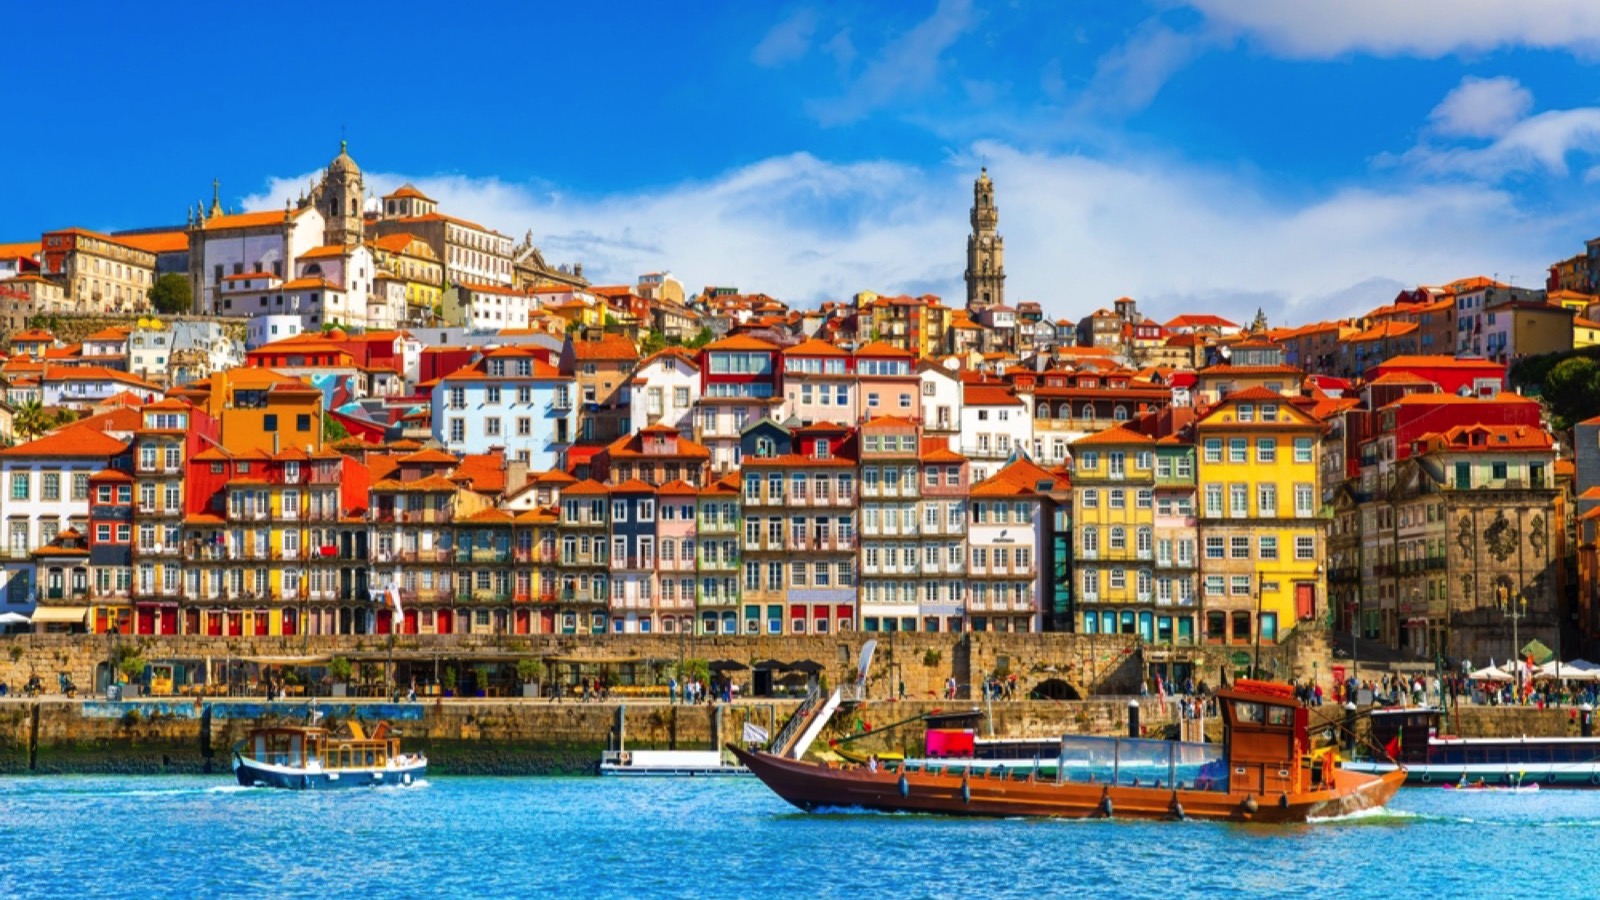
top-left (1216, 679), bottom-right (1325, 796)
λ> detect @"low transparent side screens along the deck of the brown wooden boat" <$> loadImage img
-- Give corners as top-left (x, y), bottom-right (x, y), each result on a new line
top-left (918, 735), bottom-right (1229, 793)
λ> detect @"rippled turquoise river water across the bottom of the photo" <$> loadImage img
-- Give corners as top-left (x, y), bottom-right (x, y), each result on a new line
top-left (0, 777), bottom-right (1600, 900)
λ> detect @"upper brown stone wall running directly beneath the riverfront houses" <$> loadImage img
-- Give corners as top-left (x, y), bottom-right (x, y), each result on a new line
top-left (0, 631), bottom-right (1330, 700)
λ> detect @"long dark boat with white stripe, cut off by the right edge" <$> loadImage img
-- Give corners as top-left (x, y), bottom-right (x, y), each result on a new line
top-left (1346, 706), bottom-right (1600, 788)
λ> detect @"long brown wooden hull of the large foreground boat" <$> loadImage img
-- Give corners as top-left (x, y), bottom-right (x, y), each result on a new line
top-left (730, 748), bottom-right (1405, 822)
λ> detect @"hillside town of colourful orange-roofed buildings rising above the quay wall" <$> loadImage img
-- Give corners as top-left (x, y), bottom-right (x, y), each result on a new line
top-left (0, 146), bottom-right (1600, 672)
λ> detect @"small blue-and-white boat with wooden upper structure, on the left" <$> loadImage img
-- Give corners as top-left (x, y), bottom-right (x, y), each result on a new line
top-left (234, 722), bottom-right (427, 791)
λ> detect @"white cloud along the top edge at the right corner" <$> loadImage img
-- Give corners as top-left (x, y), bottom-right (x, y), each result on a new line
top-left (1182, 0), bottom-right (1600, 59)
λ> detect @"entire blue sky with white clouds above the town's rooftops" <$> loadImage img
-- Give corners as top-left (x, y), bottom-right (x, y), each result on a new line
top-left (9, 0), bottom-right (1600, 322)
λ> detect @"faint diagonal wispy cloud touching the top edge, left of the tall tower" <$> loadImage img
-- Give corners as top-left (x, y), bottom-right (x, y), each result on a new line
top-left (806, 0), bottom-right (974, 125)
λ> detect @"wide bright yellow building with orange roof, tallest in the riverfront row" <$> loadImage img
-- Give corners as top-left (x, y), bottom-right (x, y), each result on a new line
top-left (1195, 388), bottom-right (1326, 647)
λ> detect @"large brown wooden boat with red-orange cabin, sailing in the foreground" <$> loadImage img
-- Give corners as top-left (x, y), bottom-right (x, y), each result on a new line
top-left (730, 681), bottom-right (1405, 822)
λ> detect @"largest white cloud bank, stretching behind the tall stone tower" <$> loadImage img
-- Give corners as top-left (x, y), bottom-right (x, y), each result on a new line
top-left (246, 144), bottom-right (1571, 329)
